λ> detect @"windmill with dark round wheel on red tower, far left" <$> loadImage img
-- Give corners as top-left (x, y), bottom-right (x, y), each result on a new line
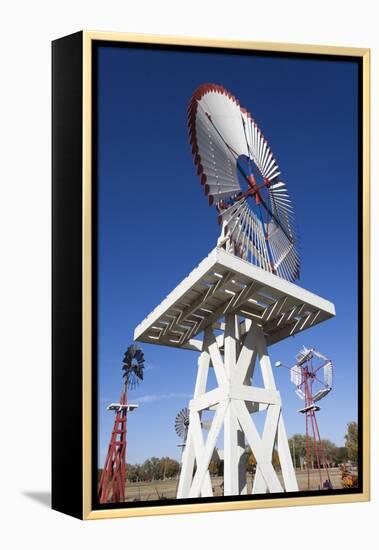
top-left (98, 344), bottom-right (144, 504)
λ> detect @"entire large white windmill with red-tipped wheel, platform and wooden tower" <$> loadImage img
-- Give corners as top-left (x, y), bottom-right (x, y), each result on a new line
top-left (134, 84), bottom-right (335, 498)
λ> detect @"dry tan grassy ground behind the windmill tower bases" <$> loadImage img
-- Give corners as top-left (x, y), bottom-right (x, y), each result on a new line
top-left (126, 468), bottom-right (348, 502)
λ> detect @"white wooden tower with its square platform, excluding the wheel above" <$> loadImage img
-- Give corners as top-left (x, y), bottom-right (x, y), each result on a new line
top-left (134, 248), bottom-right (335, 498)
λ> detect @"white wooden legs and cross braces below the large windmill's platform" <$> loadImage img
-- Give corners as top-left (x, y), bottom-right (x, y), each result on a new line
top-left (177, 315), bottom-right (298, 498)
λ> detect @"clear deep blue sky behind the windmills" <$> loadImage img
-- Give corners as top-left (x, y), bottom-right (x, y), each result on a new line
top-left (98, 47), bottom-right (358, 465)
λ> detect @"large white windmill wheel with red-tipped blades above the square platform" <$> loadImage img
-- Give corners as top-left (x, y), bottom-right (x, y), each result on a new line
top-left (188, 84), bottom-right (300, 281)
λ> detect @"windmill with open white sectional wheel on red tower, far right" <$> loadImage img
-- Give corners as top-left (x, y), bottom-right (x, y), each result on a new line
top-left (276, 347), bottom-right (333, 489)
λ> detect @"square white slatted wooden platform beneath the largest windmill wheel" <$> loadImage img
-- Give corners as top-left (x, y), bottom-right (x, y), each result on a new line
top-left (134, 248), bottom-right (335, 351)
